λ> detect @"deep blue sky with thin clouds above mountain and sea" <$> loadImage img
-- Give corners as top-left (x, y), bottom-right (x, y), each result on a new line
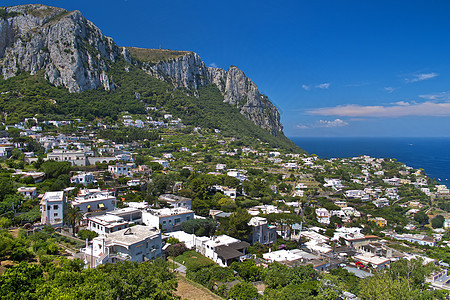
top-left (2, 0), bottom-right (450, 137)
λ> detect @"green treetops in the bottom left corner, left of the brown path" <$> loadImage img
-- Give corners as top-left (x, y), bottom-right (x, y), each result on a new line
top-left (0, 259), bottom-right (178, 299)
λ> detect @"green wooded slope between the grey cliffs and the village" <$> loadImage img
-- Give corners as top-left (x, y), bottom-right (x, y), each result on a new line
top-left (0, 60), bottom-right (302, 152)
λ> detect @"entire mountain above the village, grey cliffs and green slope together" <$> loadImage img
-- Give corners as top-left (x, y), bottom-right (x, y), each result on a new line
top-left (0, 4), bottom-right (302, 151)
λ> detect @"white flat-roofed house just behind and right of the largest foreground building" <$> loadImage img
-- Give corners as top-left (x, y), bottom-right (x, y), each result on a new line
top-left (142, 207), bottom-right (194, 232)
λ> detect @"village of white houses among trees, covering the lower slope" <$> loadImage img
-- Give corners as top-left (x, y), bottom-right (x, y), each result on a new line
top-left (0, 111), bottom-right (450, 299)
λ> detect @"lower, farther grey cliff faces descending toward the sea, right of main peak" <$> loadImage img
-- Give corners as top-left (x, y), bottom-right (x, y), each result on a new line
top-left (143, 53), bottom-right (283, 136)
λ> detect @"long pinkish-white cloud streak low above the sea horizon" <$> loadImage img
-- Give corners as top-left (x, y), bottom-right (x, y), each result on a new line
top-left (308, 101), bottom-right (450, 117)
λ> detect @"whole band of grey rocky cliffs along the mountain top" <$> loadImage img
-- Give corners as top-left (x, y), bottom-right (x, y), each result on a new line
top-left (0, 4), bottom-right (282, 136)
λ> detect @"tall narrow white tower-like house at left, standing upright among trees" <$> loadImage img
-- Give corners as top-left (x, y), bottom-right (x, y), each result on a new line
top-left (40, 191), bottom-right (66, 226)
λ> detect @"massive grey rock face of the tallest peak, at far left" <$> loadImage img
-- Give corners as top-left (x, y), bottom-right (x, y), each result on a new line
top-left (0, 4), bottom-right (121, 92)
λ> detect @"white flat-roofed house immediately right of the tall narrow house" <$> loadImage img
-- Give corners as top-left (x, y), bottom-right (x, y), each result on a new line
top-left (71, 189), bottom-right (116, 213)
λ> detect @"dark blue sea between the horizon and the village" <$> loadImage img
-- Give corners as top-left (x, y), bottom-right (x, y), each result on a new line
top-left (290, 137), bottom-right (450, 186)
